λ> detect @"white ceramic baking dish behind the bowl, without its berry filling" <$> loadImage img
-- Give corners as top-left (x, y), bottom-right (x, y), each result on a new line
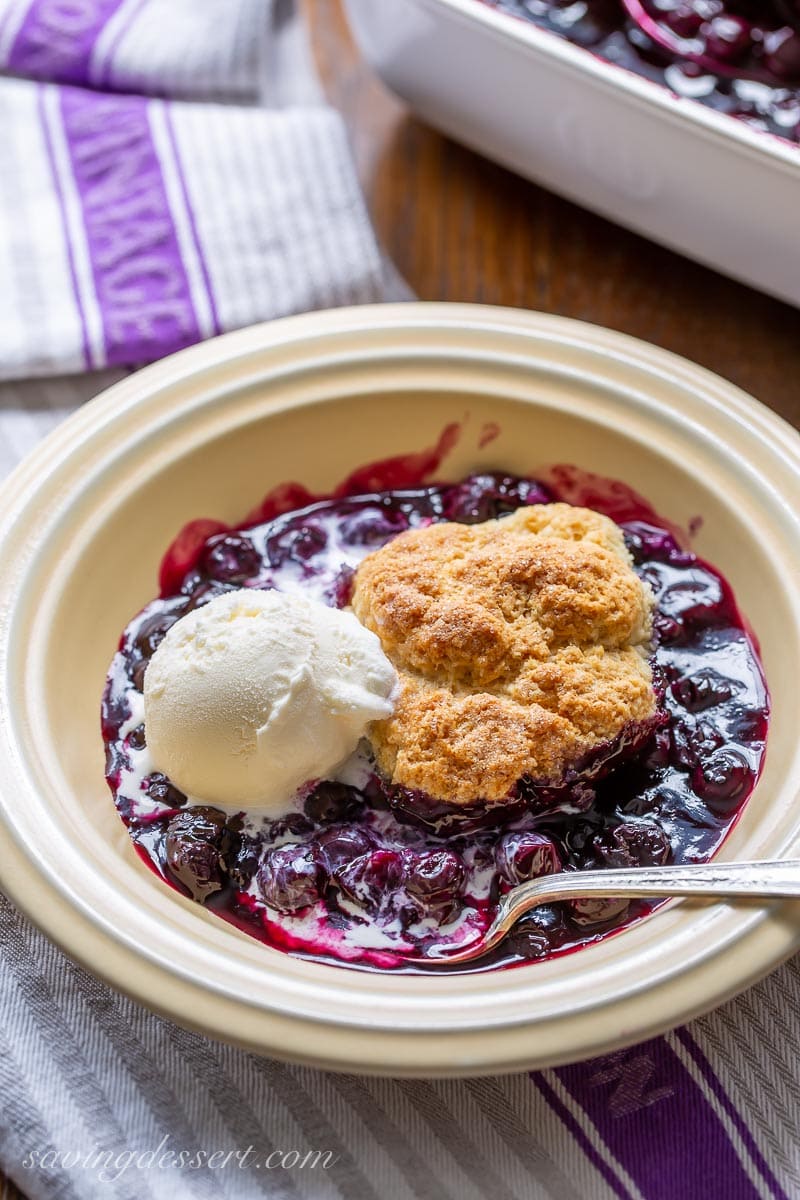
top-left (345, 0), bottom-right (800, 305)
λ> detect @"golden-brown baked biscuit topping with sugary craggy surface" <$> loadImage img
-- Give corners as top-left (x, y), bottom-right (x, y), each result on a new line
top-left (353, 504), bottom-right (656, 805)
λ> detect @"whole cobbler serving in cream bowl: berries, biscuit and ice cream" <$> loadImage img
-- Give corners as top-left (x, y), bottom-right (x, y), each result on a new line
top-left (103, 468), bottom-right (768, 971)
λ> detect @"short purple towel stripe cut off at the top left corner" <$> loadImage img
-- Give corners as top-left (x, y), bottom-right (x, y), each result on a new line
top-left (7, 0), bottom-right (122, 83)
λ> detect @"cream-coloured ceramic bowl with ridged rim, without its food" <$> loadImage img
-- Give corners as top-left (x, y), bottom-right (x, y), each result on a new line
top-left (0, 304), bottom-right (800, 1075)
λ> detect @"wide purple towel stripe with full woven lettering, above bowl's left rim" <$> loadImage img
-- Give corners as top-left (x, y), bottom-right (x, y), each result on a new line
top-left (61, 88), bottom-right (201, 366)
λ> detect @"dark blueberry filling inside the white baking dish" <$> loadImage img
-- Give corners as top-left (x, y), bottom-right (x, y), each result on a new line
top-left (483, 0), bottom-right (800, 143)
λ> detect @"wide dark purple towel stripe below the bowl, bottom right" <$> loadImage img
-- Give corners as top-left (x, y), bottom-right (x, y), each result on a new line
top-left (544, 1038), bottom-right (760, 1200)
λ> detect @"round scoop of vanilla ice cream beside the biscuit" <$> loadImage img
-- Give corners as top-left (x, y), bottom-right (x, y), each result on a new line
top-left (144, 589), bottom-right (397, 816)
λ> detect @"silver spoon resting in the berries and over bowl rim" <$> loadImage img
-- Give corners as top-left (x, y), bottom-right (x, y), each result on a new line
top-left (403, 859), bottom-right (800, 966)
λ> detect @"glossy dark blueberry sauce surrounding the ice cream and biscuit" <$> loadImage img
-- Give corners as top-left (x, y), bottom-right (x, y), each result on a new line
top-left (102, 468), bottom-right (769, 971)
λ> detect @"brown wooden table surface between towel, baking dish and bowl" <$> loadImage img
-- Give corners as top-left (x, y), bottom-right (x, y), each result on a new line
top-left (0, 0), bottom-right (800, 1200)
